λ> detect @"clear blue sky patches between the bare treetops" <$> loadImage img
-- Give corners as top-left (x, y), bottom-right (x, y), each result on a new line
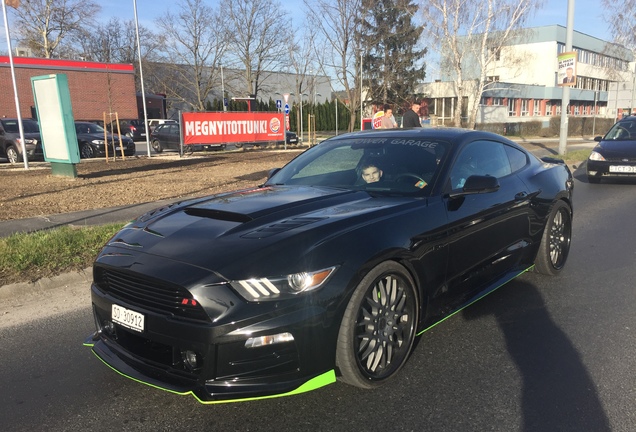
top-left (0, 0), bottom-right (611, 51)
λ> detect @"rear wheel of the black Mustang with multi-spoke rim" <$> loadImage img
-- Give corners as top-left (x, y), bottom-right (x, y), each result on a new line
top-left (534, 201), bottom-right (572, 276)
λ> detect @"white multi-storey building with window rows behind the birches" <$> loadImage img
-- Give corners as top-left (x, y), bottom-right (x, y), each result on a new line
top-left (420, 25), bottom-right (636, 124)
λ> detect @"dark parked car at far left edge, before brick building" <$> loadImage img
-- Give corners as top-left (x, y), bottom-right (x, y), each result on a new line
top-left (0, 118), bottom-right (44, 164)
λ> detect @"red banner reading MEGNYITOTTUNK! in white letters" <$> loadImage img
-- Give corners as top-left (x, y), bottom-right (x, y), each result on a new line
top-left (182, 112), bottom-right (285, 145)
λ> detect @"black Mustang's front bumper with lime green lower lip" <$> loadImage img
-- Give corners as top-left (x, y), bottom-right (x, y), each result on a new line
top-left (84, 284), bottom-right (335, 403)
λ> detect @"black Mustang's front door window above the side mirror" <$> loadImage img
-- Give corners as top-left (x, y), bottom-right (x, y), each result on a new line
top-left (450, 141), bottom-right (512, 189)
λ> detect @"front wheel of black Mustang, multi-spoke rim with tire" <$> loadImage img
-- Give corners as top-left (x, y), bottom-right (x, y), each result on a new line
top-left (336, 261), bottom-right (419, 389)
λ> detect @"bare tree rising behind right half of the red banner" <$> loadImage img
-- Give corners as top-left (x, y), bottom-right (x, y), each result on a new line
top-left (221, 0), bottom-right (289, 97)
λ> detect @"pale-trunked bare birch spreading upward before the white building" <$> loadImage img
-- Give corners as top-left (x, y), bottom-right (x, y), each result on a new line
top-left (420, 0), bottom-right (540, 128)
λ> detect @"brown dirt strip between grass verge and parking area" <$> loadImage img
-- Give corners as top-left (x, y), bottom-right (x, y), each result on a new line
top-left (0, 149), bottom-right (304, 220)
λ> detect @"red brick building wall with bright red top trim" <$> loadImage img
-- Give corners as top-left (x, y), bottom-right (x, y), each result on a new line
top-left (0, 56), bottom-right (138, 120)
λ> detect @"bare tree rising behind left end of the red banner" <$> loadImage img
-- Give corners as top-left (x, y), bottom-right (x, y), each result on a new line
top-left (151, 0), bottom-right (226, 111)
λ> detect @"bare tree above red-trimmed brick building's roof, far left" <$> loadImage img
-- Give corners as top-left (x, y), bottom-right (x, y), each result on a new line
top-left (7, 0), bottom-right (101, 58)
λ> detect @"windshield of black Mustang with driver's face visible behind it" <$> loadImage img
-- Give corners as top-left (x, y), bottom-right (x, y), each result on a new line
top-left (267, 135), bottom-right (450, 194)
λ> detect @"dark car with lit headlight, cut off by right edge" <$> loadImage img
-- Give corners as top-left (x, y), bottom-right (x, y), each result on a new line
top-left (587, 116), bottom-right (636, 183)
